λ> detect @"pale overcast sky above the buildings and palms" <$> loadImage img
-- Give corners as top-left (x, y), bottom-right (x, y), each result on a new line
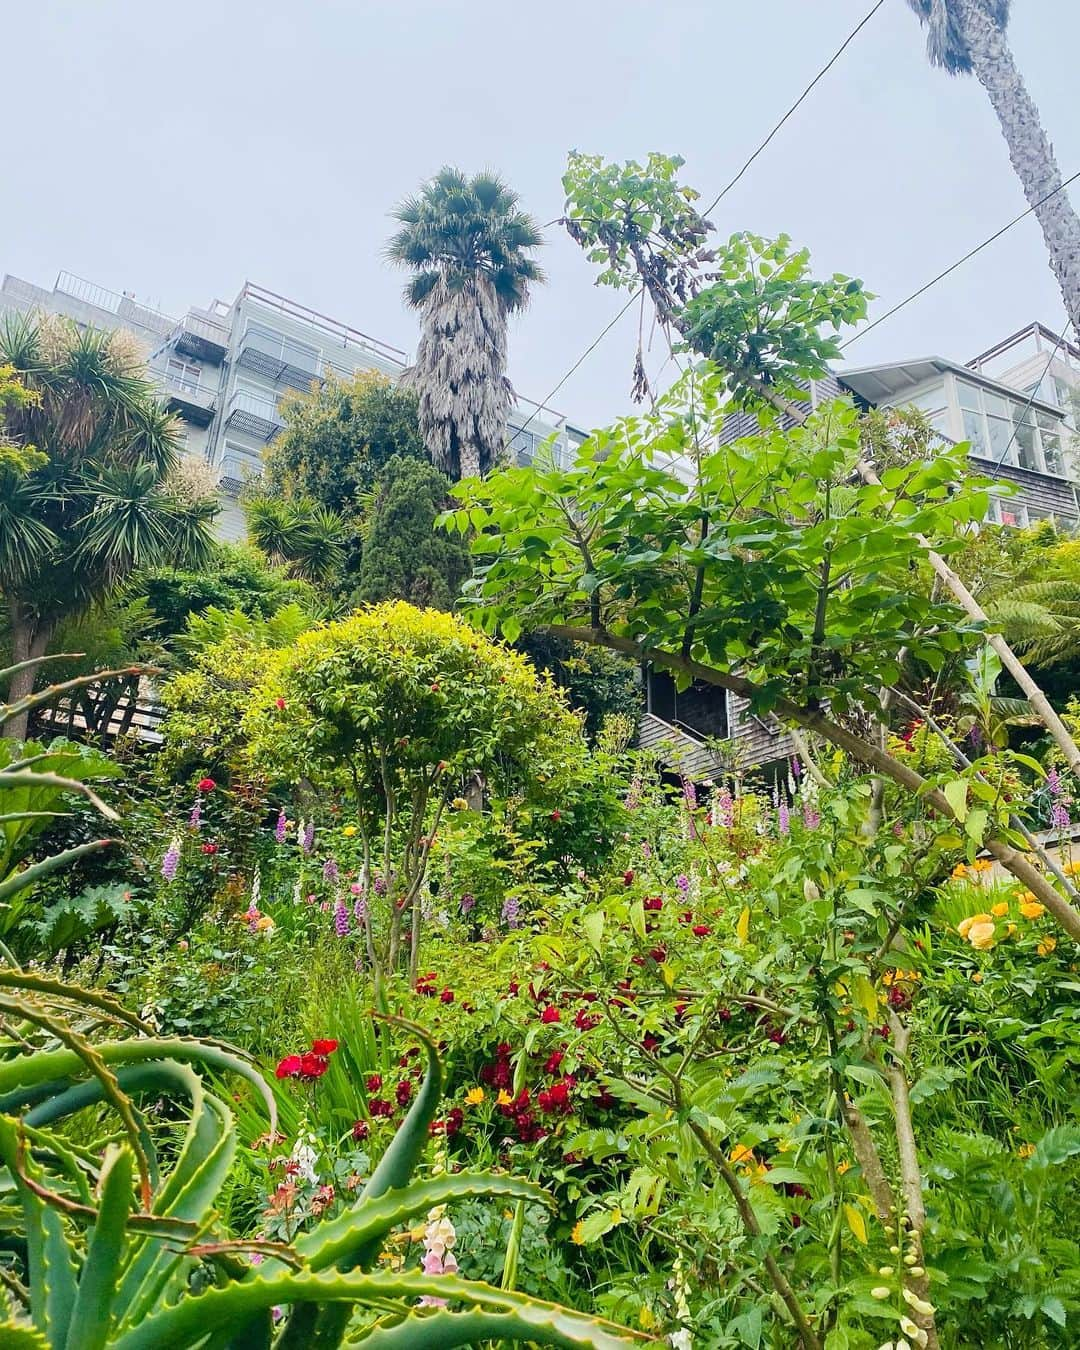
top-left (0, 0), bottom-right (1080, 425)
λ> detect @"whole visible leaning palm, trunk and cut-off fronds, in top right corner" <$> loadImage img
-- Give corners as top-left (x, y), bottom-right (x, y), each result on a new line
top-left (907, 0), bottom-right (1080, 332)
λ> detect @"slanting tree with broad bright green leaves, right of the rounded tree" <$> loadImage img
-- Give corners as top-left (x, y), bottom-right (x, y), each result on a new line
top-left (450, 373), bottom-right (1080, 938)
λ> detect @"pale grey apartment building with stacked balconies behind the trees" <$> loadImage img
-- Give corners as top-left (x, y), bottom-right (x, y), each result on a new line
top-left (0, 271), bottom-right (585, 540)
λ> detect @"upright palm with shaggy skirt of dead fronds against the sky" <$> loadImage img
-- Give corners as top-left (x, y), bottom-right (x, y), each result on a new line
top-left (387, 169), bottom-right (544, 479)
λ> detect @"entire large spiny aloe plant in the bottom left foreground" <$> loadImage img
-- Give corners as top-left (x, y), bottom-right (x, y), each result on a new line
top-left (0, 968), bottom-right (640, 1350)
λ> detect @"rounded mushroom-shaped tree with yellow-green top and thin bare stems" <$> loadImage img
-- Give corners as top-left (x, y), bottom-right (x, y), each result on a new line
top-left (243, 602), bottom-right (581, 979)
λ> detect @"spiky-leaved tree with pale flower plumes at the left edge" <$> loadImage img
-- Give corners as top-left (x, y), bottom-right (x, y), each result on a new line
top-left (0, 315), bottom-right (217, 738)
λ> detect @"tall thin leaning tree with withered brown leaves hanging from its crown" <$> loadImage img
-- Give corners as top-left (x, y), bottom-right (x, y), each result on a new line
top-left (563, 153), bottom-right (1080, 776)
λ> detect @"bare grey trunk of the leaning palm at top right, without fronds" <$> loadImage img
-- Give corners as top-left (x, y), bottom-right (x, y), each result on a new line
top-left (956, 0), bottom-right (1080, 332)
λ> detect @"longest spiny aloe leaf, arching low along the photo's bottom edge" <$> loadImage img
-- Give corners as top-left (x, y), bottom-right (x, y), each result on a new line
top-left (109, 1270), bottom-right (644, 1350)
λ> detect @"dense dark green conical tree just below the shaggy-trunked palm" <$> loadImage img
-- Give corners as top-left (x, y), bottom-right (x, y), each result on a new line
top-left (352, 456), bottom-right (471, 609)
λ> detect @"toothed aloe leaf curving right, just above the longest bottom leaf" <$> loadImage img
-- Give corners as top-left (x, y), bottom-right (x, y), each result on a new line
top-left (294, 1172), bottom-right (551, 1270)
